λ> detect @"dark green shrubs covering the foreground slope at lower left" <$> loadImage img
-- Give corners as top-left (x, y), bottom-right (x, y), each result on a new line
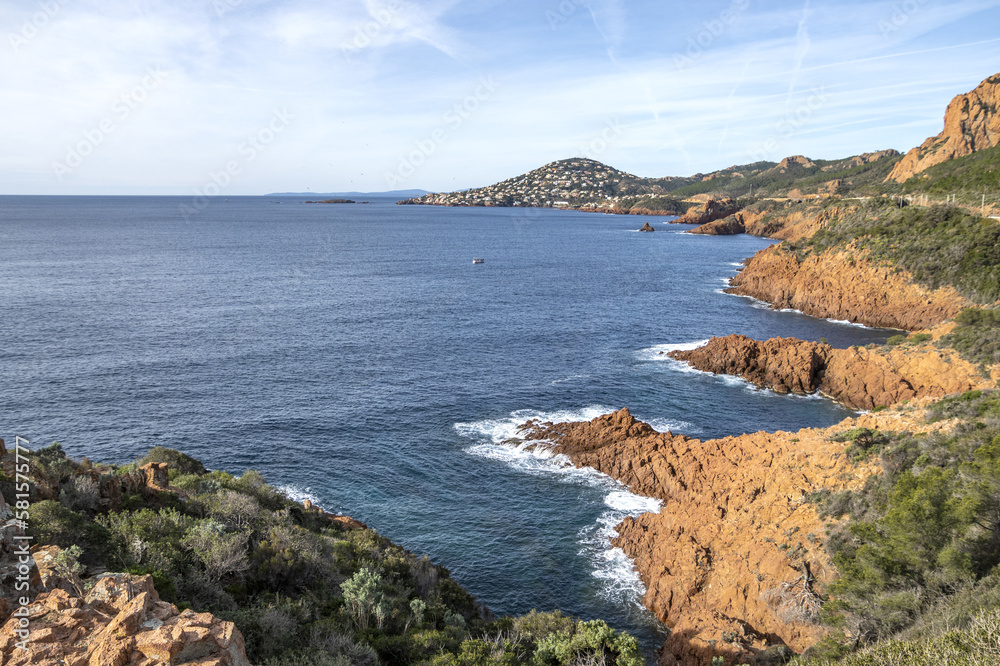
top-left (17, 444), bottom-right (643, 666)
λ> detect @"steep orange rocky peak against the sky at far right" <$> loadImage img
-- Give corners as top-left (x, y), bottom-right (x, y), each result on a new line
top-left (886, 74), bottom-right (1000, 183)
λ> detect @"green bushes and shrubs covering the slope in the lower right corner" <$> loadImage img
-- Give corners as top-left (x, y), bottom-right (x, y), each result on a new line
top-left (798, 391), bottom-right (1000, 666)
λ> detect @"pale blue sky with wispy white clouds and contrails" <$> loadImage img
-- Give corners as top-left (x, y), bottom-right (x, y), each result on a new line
top-left (0, 0), bottom-right (1000, 196)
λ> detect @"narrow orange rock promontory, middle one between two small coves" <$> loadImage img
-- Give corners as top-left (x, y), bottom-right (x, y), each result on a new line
top-left (670, 335), bottom-right (990, 409)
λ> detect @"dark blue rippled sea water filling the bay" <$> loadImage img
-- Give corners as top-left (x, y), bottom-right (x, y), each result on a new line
top-left (0, 197), bottom-right (890, 649)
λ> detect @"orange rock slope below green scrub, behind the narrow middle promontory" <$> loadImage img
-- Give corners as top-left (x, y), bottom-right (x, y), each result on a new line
top-left (726, 246), bottom-right (971, 331)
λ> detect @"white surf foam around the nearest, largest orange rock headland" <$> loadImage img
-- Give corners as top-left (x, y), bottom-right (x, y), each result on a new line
top-left (455, 405), bottom-right (661, 608)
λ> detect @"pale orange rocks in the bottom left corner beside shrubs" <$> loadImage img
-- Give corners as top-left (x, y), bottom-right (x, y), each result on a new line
top-left (0, 574), bottom-right (250, 666)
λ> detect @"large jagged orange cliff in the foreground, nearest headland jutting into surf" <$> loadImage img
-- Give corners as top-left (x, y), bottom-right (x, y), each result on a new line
top-left (526, 410), bottom-right (944, 666)
